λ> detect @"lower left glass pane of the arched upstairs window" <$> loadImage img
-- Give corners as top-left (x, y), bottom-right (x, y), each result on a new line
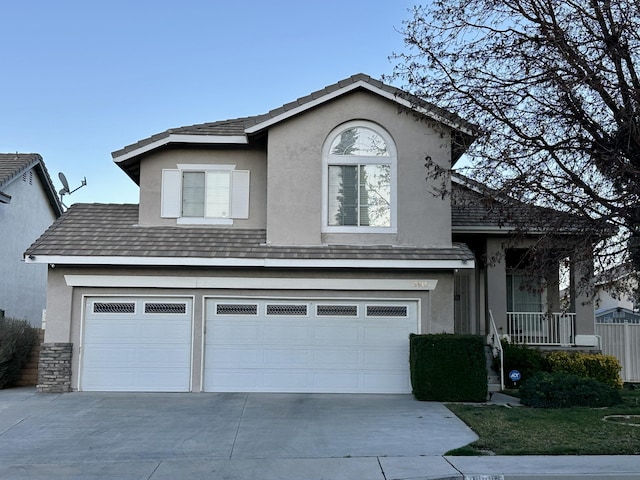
top-left (329, 165), bottom-right (358, 226)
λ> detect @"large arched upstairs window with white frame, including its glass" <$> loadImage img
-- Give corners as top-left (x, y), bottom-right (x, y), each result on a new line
top-left (323, 121), bottom-right (396, 233)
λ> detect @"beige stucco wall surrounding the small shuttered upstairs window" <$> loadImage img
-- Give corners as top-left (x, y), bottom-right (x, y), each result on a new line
top-left (139, 146), bottom-right (267, 228)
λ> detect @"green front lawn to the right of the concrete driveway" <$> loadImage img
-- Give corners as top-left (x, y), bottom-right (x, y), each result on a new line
top-left (447, 390), bottom-right (640, 455)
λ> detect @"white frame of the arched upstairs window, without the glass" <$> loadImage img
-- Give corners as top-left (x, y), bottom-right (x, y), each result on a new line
top-left (321, 120), bottom-right (398, 233)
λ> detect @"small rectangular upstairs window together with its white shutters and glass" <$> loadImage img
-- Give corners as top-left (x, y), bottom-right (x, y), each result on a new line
top-left (161, 165), bottom-right (249, 225)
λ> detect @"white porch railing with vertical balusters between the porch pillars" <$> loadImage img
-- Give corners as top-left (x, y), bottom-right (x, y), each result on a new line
top-left (507, 312), bottom-right (576, 346)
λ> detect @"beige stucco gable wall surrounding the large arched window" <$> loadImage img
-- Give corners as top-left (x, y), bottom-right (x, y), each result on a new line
top-left (267, 92), bottom-right (451, 246)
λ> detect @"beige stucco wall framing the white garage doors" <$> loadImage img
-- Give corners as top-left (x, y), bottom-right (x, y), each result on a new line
top-left (45, 266), bottom-right (454, 391)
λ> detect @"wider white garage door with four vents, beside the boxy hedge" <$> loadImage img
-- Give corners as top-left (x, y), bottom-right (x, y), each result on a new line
top-left (204, 299), bottom-right (418, 393)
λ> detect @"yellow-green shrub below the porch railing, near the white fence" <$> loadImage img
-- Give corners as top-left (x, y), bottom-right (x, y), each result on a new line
top-left (547, 352), bottom-right (622, 389)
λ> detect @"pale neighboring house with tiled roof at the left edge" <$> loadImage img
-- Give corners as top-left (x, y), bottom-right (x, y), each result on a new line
top-left (0, 153), bottom-right (62, 327)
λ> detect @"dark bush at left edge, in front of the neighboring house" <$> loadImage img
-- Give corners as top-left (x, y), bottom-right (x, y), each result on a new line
top-left (0, 317), bottom-right (38, 388)
